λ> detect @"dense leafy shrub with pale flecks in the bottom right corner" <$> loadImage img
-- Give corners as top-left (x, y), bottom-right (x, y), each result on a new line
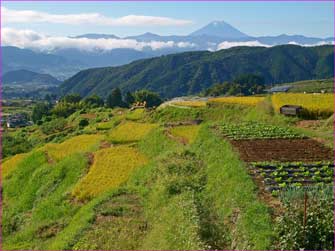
top-left (275, 187), bottom-right (334, 250)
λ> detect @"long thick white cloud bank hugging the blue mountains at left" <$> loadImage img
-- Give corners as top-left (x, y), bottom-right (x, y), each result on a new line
top-left (1, 28), bottom-right (195, 51)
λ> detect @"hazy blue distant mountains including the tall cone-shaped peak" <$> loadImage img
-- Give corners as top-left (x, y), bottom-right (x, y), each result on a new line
top-left (2, 21), bottom-right (333, 80)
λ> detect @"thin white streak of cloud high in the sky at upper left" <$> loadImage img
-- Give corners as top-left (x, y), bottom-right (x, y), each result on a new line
top-left (1, 7), bottom-right (192, 26)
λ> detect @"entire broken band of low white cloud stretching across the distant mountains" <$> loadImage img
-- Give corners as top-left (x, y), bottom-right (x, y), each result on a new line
top-left (1, 28), bottom-right (334, 52)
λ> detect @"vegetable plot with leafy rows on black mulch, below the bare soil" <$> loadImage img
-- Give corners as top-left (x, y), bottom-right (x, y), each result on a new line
top-left (250, 162), bottom-right (334, 195)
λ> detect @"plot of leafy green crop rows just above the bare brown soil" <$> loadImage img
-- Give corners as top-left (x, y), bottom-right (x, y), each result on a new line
top-left (216, 122), bottom-right (304, 140)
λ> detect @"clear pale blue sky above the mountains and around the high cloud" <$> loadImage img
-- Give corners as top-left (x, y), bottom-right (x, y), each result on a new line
top-left (2, 2), bottom-right (334, 37)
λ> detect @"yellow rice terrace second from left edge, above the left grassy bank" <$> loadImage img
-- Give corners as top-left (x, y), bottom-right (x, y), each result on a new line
top-left (39, 134), bottom-right (104, 161)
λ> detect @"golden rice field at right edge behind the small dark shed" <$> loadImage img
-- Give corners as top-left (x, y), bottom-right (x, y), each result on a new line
top-left (272, 93), bottom-right (334, 117)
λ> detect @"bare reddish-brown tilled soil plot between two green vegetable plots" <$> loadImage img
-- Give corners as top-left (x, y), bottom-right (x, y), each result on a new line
top-left (231, 139), bottom-right (334, 162)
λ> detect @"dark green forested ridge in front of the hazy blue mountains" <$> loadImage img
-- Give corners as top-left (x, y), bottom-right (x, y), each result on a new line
top-left (61, 45), bottom-right (334, 98)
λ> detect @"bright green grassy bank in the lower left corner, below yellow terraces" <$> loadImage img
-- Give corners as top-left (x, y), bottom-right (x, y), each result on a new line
top-left (3, 152), bottom-right (87, 249)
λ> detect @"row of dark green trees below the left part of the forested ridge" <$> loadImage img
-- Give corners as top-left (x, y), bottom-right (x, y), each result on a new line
top-left (32, 88), bottom-right (162, 123)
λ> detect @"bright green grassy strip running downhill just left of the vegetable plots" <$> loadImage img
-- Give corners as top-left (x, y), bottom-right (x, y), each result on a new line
top-left (193, 125), bottom-right (272, 250)
